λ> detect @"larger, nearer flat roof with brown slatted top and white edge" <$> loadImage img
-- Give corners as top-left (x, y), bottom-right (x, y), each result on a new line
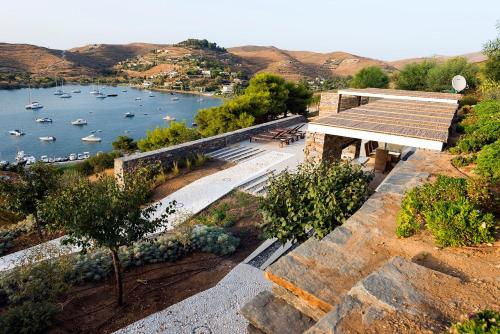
top-left (309, 96), bottom-right (458, 150)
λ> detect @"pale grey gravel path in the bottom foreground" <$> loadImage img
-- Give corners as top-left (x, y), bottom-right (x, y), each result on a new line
top-left (115, 264), bottom-right (271, 334)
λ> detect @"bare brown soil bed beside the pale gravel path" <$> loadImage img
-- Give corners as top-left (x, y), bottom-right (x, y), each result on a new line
top-left (50, 195), bottom-right (262, 334)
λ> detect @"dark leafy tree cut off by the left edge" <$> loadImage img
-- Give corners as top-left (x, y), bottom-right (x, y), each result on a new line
top-left (0, 162), bottom-right (62, 239)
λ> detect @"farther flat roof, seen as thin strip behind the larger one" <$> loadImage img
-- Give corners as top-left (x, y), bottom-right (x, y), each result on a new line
top-left (338, 88), bottom-right (462, 104)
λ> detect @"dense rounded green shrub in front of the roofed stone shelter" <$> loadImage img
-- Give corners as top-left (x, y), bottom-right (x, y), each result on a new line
top-left (261, 161), bottom-right (372, 243)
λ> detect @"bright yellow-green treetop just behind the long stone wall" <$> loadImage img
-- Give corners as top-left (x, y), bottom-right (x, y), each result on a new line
top-left (137, 122), bottom-right (200, 152)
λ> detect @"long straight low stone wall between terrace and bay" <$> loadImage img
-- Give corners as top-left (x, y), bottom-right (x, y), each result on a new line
top-left (115, 115), bottom-right (306, 176)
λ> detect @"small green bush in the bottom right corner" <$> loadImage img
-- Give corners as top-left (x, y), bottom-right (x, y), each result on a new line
top-left (450, 310), bottom-right (500, 334)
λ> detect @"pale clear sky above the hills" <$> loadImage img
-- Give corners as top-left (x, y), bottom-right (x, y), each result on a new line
top-left (0, 0), bottom-right (500, 60)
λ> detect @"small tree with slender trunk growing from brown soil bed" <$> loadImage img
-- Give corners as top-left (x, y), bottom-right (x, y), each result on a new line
top-left (42, 168), bottom-right (174, 305)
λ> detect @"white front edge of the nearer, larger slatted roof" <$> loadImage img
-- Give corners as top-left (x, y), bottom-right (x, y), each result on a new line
top-left (307, 122), bottom-right (444, 151)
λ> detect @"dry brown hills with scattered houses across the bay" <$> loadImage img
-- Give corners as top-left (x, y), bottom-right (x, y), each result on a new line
top-left (0, 40), bottom-right (485, 89)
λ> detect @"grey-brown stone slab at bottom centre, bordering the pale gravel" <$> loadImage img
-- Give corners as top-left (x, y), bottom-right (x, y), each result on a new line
top-left (240, 291), bottom-right (314, 334)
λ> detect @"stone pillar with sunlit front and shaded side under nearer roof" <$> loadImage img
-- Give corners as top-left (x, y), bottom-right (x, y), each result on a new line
top-left (304, 131), bottom-right (361, 162)
